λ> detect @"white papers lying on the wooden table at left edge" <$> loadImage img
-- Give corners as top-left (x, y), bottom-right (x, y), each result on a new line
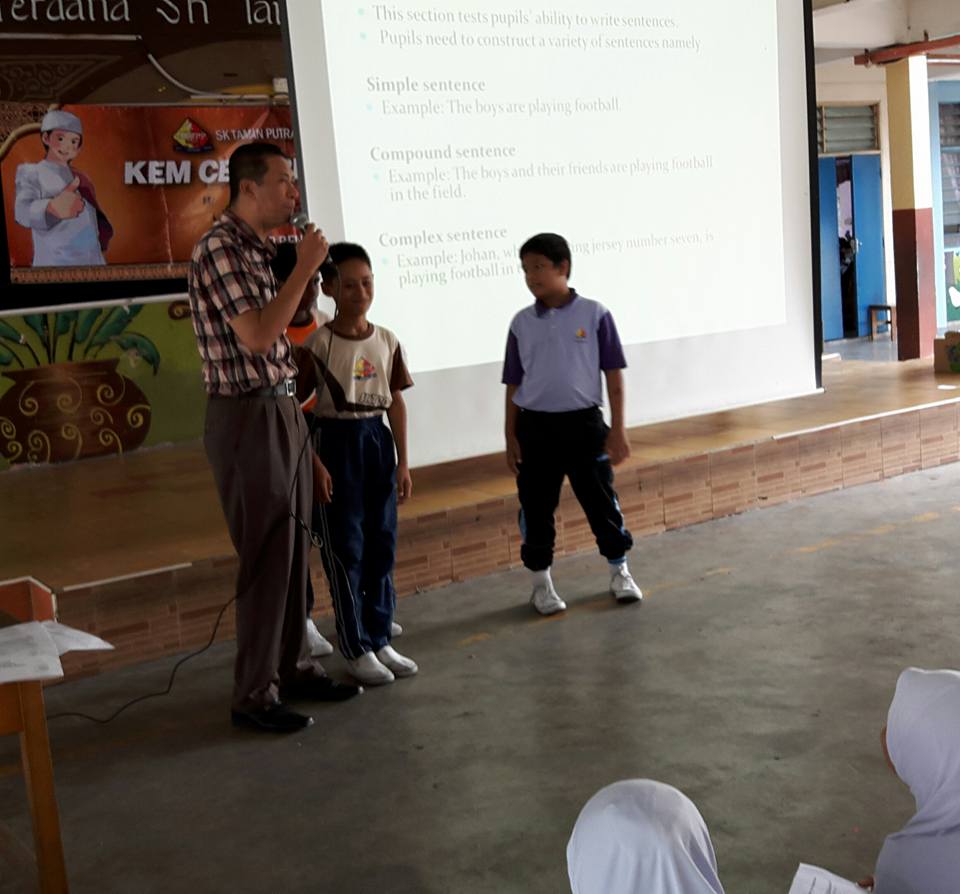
top-left (0, 621), bottom-right (113, 683)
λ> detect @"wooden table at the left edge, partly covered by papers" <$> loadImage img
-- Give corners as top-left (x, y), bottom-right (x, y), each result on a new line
top-left (0, 581), bottom-right (67, 894)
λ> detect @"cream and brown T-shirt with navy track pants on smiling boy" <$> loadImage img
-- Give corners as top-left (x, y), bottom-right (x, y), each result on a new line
top-left (304, 324), bottom-right (413, 659)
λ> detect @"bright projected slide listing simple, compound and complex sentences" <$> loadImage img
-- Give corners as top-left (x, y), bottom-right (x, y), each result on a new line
top-left (288, 0), bottom-right (785, 371)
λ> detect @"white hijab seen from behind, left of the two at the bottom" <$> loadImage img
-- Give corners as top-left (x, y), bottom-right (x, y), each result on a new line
top-left (567, 779), bottom-right (723, 894)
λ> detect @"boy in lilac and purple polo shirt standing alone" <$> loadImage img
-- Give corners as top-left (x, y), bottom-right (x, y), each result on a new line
top-left (503, 233), bottom-right (643, 615)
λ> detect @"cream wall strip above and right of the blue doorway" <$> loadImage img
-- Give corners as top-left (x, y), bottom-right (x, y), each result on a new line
top-left (817, 59), bottom-right (897, 304)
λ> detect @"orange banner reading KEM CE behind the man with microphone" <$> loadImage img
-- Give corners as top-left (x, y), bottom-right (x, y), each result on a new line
top-left (0, 105), bottom-right (294, 290)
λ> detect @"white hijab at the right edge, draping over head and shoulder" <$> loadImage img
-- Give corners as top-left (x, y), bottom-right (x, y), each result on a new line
top-left (875, 668), bottom-right (960, 894)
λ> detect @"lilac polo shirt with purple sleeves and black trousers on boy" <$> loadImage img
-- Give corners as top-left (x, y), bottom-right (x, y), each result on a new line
top-left (503, 289), bottom-right (633, 571)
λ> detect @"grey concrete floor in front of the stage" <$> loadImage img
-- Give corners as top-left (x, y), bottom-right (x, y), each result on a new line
top-left (0, 465), bottom-right (960, 894)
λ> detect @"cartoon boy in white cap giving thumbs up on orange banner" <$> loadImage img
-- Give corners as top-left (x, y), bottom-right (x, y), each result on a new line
top-left (15, 110), bottom-right (113, 267)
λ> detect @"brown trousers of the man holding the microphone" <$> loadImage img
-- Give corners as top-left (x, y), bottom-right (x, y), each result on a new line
top-left (203, 397), bottom-right (323, 711)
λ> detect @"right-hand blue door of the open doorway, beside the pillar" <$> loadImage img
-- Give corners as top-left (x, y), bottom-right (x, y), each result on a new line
top-left (853, 155), bottom-right (887, 335)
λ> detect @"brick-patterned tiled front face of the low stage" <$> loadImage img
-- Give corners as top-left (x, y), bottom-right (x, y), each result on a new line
top-left (45, 399), bottom-right (960, 679)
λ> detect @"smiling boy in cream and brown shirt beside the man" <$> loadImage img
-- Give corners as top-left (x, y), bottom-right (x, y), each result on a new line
top-left (301, 243), bottom-right (418, 686)
